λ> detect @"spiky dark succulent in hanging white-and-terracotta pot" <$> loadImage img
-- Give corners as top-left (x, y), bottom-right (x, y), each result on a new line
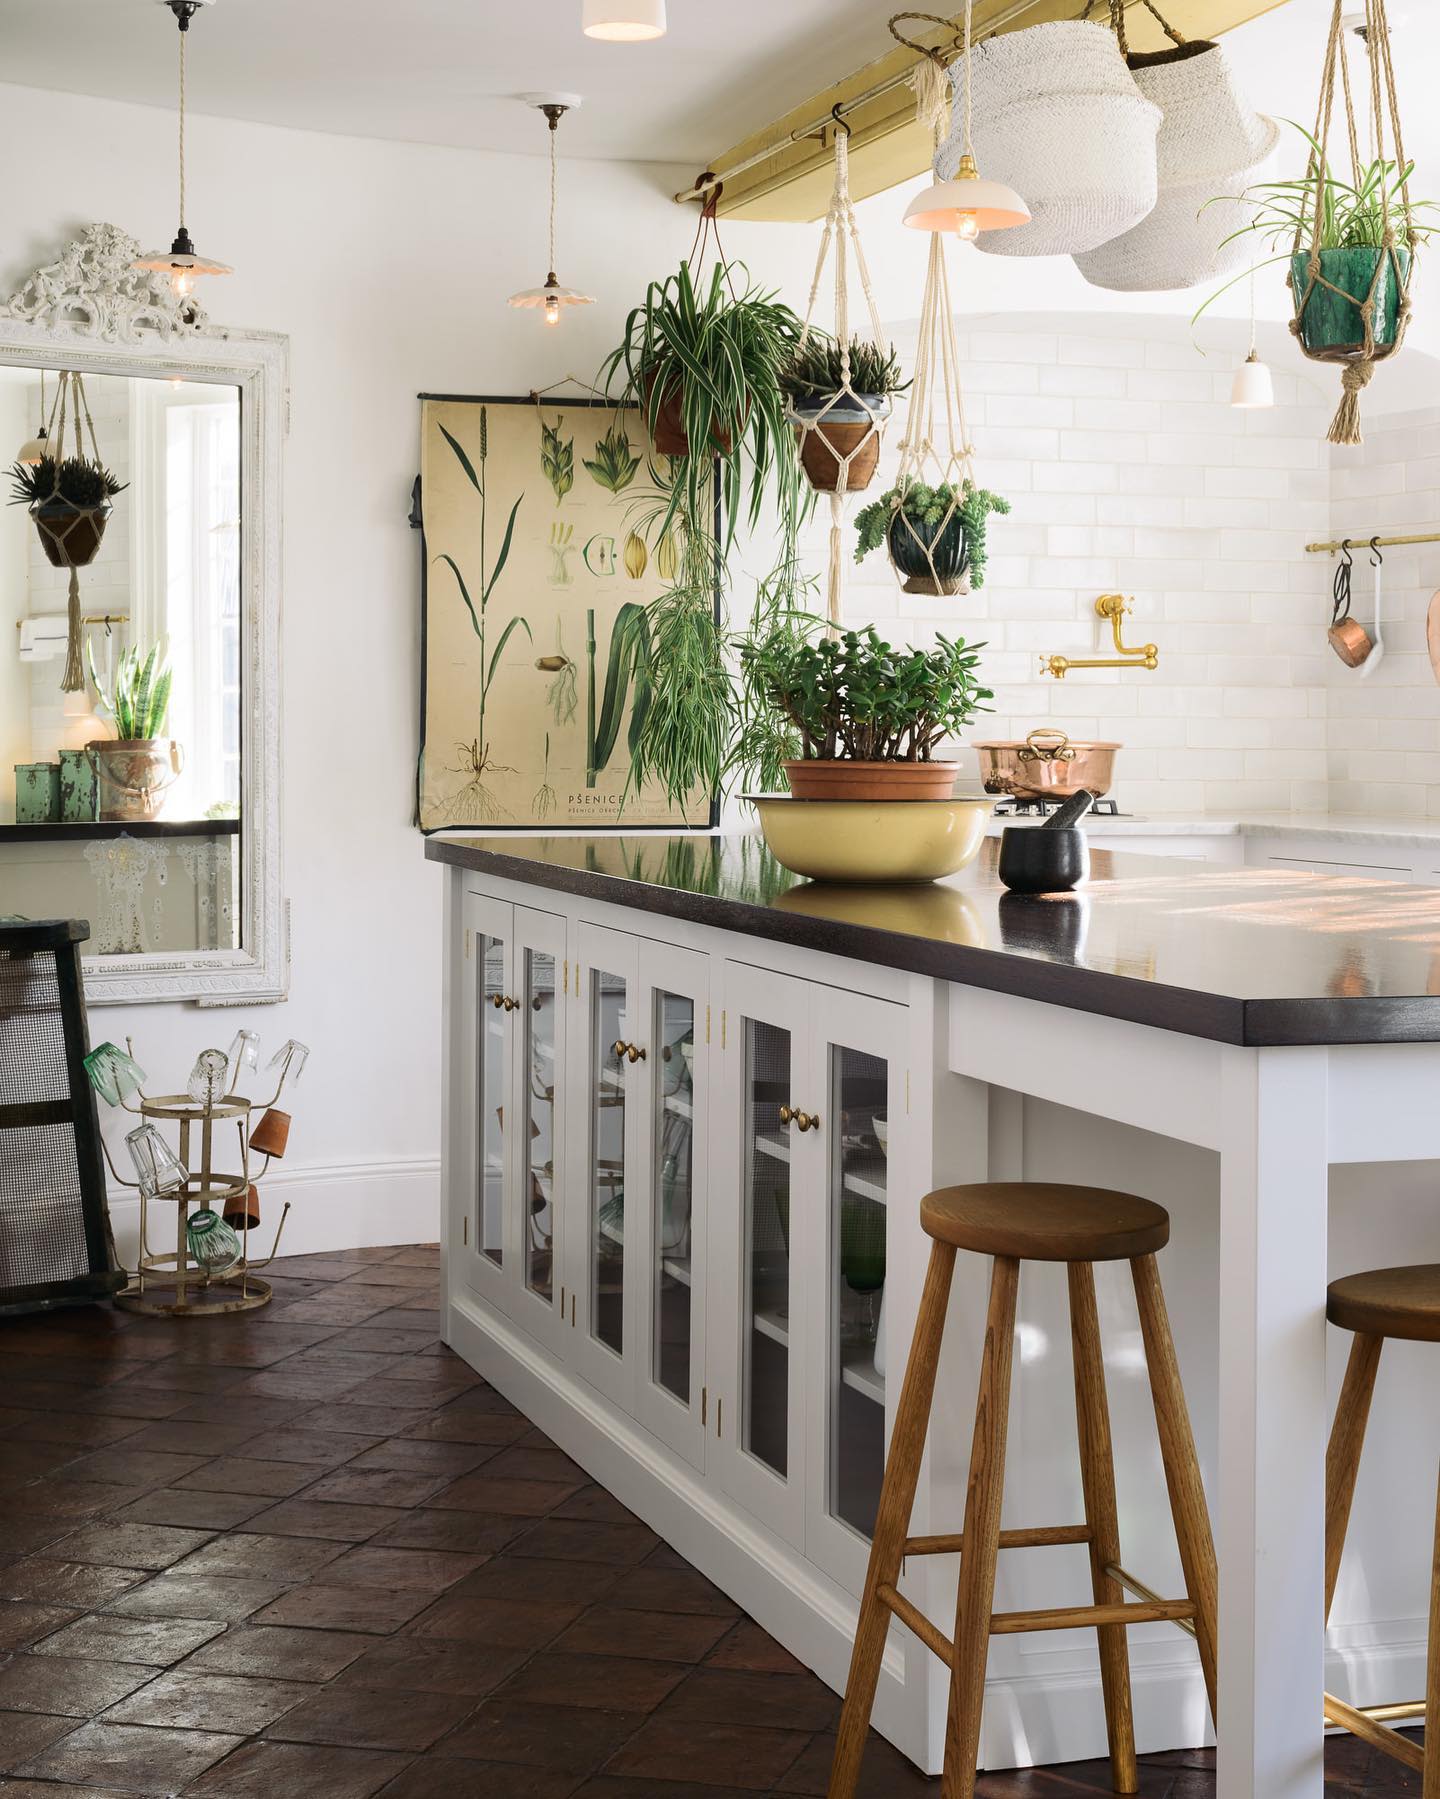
top-left (779, 331), bottom-right (909, 493)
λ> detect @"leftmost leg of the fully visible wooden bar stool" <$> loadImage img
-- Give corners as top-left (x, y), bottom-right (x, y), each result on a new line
top-left (828, 1243), bottom-right (956, 1799)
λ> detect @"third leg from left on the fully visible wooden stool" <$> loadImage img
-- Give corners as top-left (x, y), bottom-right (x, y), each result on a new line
top-left (1069, 1261), bottom-right (1139, 1794)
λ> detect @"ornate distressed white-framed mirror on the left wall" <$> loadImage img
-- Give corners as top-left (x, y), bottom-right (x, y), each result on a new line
top-left (0, 225), bottom-right (288, 1004)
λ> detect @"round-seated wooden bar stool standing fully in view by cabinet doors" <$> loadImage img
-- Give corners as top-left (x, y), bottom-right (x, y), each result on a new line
top-left (828, 1180), bottom-right (1215, 1799)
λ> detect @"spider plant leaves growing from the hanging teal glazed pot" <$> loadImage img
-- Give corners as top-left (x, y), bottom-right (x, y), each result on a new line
top-left (1190, 119), bottom-right (1436, 324)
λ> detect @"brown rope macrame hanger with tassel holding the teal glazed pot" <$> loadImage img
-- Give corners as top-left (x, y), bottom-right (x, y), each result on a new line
top-left (1291, 0), bottom-right (1417, 444)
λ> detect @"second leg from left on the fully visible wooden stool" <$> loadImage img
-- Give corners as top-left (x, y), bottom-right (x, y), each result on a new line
top-left (941, 1256), bottom-right (1021, 1799)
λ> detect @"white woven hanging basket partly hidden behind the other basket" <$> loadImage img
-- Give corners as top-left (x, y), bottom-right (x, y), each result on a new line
top-left (1075, 43), bottom-right (1280, 293)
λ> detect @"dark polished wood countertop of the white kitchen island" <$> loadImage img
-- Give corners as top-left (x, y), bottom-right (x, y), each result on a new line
top-left (425, 835), bottom-right (1440, 1047)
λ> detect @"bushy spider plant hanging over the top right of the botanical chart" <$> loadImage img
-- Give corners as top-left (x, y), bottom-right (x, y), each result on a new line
top-left (601, 261), bottom-right (805, 552)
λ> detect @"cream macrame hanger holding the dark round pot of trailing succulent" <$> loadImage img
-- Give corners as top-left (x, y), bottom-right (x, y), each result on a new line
top-left (886, 0), bottom-right (976, 594)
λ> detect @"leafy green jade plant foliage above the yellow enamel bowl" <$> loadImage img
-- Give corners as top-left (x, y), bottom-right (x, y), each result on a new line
top-left (740, 624), bottom-right (994, 763)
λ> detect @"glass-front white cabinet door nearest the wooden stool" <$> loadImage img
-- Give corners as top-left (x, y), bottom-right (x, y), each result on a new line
top-left (805, 988), bottom-right (907, 1592)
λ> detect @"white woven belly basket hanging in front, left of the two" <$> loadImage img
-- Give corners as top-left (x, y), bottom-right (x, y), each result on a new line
top-left (934, 20), bottom-right (1161, 255)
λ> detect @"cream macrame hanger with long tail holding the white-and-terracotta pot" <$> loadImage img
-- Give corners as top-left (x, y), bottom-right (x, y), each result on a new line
top-left (788, 106), bottom-right (889, 635)
